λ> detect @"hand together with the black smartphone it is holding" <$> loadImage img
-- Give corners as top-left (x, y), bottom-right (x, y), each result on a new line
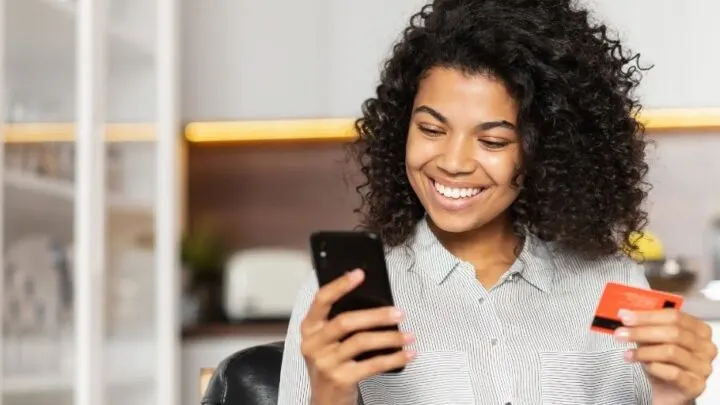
top-left (300, 232), bottom-right (415, 405)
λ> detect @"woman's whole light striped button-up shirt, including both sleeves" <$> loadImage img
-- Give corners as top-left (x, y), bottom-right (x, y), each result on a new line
top-left (279, 220), bottom-right (651, 405)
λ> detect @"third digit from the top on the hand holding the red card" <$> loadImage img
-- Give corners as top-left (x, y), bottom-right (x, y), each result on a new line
top-left (626, 344), bottom-right (712, 378)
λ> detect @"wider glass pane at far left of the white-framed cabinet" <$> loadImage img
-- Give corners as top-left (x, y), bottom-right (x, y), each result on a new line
top-left (0, 0), bottom-right (76, 405)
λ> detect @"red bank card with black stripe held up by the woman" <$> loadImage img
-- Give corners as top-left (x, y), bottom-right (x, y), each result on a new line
top-left (590, 283), bottom-right (685, 334)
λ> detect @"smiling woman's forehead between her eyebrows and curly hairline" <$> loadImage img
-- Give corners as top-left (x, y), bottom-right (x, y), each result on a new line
top-left (415, 67), bottom-right (517, 125)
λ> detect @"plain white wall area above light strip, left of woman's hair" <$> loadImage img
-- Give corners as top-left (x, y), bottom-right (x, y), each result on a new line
top-left (182, 0), bottom-right (423, 120)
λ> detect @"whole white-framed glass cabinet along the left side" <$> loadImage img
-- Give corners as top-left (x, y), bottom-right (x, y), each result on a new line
top-left (0, 0), bottom-right (181, 405)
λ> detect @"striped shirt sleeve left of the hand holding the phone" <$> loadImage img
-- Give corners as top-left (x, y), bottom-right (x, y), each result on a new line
top-left (278, 274), bottom-right (318, 405)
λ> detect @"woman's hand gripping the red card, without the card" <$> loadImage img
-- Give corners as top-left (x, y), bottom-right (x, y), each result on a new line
top-left (615, 309), bottom-right (718, 405)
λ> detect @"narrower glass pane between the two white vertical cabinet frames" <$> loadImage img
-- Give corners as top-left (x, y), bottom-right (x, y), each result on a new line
top-left (105, 0), bottom-right (157, 405)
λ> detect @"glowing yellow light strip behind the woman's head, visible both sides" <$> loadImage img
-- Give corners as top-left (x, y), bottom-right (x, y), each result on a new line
top-left (185, 108), bottom-right (720, 142)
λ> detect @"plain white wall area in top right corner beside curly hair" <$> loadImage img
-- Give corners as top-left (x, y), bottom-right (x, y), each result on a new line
top-left (589, 0), bottom-right (720, 107)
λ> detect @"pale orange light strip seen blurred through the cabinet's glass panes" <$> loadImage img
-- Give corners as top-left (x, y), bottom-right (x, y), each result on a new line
top-left (3, 122), bottom-right (155, 143)
